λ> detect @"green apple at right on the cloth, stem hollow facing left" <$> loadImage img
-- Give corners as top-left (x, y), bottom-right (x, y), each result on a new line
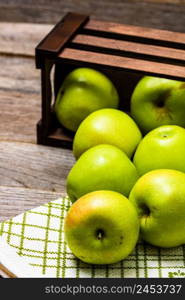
top-left (129, 169), bottom-right (185, 247)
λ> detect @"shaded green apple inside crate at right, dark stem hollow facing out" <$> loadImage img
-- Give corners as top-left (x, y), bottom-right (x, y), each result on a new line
top-left (131, 76), bottom-right (185, 133)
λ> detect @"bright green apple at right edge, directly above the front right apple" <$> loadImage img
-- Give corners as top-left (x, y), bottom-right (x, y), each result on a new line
top-left (133, 125), bottom-right (185, 175)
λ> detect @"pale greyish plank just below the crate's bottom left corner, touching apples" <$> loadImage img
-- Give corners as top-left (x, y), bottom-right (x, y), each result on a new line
top-left (0, 142), bottom-right (74, 192)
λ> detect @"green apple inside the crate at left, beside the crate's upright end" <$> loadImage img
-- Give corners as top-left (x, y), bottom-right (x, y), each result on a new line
top-left (55, 68), bottom-right (119, 131)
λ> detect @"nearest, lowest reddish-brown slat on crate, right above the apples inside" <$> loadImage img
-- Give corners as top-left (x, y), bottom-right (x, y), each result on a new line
top-left (59, 48), bottom-right (185, 80)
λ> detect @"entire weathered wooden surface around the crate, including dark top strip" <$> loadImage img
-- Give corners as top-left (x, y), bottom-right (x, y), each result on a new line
top-left (0, 0), bottom-right (185, 222)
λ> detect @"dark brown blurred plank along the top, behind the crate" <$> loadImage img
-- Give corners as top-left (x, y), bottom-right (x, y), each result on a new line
top-left (0, 0), bottom-right (185, 32)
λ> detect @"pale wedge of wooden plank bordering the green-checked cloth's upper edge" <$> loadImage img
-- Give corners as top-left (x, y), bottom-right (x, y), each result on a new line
top-left (0, 186), bottom-right (65, 222)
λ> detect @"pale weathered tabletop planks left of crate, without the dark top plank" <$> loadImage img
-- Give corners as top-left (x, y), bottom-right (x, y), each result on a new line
top-left (0, 23), bottom-right (74, 221)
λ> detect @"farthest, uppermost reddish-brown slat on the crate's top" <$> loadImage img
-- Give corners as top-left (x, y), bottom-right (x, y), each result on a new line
top-left (84, 19), bottom-right (185, 45)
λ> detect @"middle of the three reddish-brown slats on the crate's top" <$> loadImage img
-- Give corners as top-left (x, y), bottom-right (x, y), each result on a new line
top-left (72, 34), bottom-right (185, 62)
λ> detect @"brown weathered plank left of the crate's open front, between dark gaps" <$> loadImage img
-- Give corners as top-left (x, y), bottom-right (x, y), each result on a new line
top-left (0, 56), bottom-right (41, 143)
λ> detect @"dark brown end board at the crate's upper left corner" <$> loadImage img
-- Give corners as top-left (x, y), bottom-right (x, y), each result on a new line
top-left (36, 13), bottom-right (88, 68)
